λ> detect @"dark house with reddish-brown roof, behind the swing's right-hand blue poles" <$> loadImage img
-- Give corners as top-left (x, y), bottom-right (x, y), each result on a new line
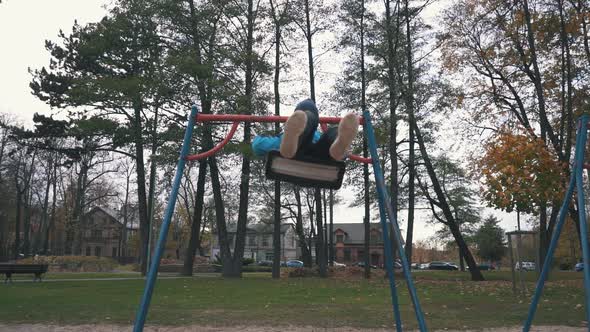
top-left (333, 223), bottom-right (384, 266)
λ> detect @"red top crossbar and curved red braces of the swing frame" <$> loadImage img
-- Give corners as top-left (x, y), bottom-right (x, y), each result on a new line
top-left (192, 114), bottom-right (373, 164)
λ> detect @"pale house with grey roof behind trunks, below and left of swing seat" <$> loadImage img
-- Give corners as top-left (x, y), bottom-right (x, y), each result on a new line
top-left (211, 224), bottom-right (300, 261)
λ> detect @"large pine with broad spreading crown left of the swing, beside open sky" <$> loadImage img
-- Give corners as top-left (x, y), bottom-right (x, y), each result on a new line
top-left (30, 0), bottom-right (178, 274)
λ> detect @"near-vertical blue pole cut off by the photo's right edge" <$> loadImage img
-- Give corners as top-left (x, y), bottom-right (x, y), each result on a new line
top-left (575, 115), bottom-right (590, 331)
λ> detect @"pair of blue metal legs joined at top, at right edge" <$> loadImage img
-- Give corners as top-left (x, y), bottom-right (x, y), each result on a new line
top-left (522, 115), bottom-right (590, 332)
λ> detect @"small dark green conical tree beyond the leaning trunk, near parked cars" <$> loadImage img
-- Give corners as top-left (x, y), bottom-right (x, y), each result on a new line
top-left (474, 215), bottom-right (506, 262)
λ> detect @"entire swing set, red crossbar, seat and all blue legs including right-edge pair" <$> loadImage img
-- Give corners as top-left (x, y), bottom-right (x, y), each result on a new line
top-left (133, 106), bottom-right (590, 332)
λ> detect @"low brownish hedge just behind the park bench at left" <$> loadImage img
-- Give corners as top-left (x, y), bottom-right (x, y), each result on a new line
top-left (19, 256), bottom-right (117, 272)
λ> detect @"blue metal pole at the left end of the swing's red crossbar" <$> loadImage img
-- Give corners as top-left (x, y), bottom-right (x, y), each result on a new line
top-left (133, 105), bottom-right (199, 332)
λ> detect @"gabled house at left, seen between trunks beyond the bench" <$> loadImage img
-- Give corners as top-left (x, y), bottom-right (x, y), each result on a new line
top-left (82, 206), bottom-right (139, 258)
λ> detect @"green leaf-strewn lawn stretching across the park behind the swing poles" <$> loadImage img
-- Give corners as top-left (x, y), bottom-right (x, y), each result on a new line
top-left (0, 271), bottom-right (585, 329)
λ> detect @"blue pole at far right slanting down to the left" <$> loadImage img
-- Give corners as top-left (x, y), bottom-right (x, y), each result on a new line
top-left (522, 116), bottom-right (588, 332)
